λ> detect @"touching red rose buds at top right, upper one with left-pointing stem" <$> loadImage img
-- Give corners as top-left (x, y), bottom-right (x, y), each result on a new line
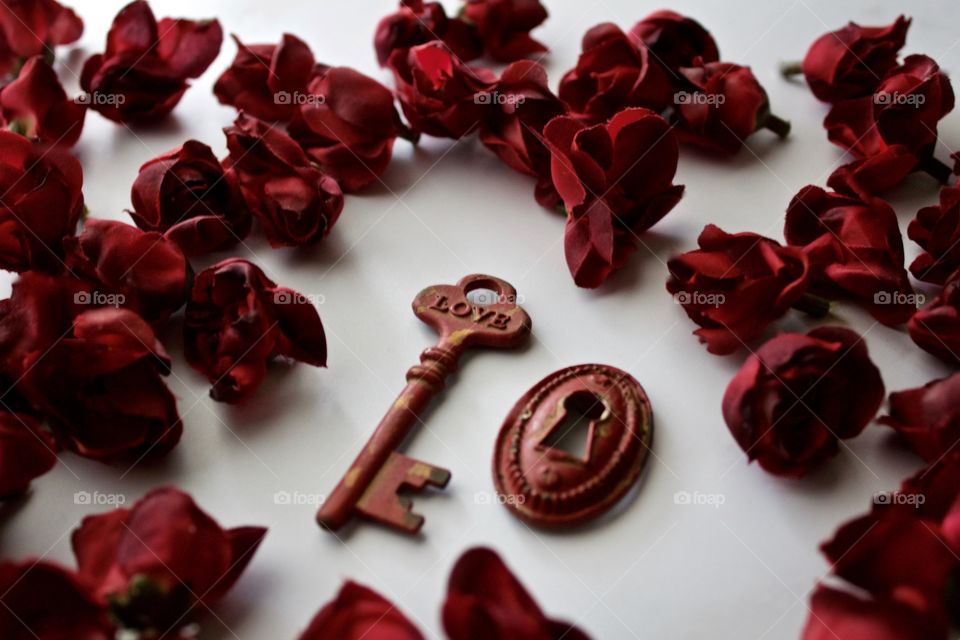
top-left (784, 16), bottom-right (954, 197)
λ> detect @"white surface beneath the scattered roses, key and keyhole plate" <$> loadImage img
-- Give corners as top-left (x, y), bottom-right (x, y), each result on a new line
top-left (0, 0), bottom-right (960, 640)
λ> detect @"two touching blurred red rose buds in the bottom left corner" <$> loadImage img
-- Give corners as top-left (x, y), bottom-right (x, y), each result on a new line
top-left (0, 487), bottom-right (267, 640)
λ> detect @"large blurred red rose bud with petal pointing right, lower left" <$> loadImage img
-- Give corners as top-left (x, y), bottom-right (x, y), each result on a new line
top-left (71, 487), bottom-right (267, 637)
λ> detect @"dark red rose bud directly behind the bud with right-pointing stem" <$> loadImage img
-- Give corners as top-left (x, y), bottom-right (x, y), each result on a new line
top-left (630, 10), bottom-right (720, 70)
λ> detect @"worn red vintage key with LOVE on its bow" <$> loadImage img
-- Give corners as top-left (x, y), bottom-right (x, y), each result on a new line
top-left (317, 274), bottom-right (531, 533)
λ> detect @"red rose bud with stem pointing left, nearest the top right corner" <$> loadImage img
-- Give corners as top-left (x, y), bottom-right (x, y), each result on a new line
top-left (783, 16), bottom-right (910, 102)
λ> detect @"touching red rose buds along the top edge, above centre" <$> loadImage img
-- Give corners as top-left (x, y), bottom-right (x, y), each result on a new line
top-left (373, 0), bottom-right (547, 67)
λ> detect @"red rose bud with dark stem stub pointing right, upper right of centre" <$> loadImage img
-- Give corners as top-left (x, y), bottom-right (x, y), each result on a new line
top-left (673, 62), bottom-right (790, 154)
